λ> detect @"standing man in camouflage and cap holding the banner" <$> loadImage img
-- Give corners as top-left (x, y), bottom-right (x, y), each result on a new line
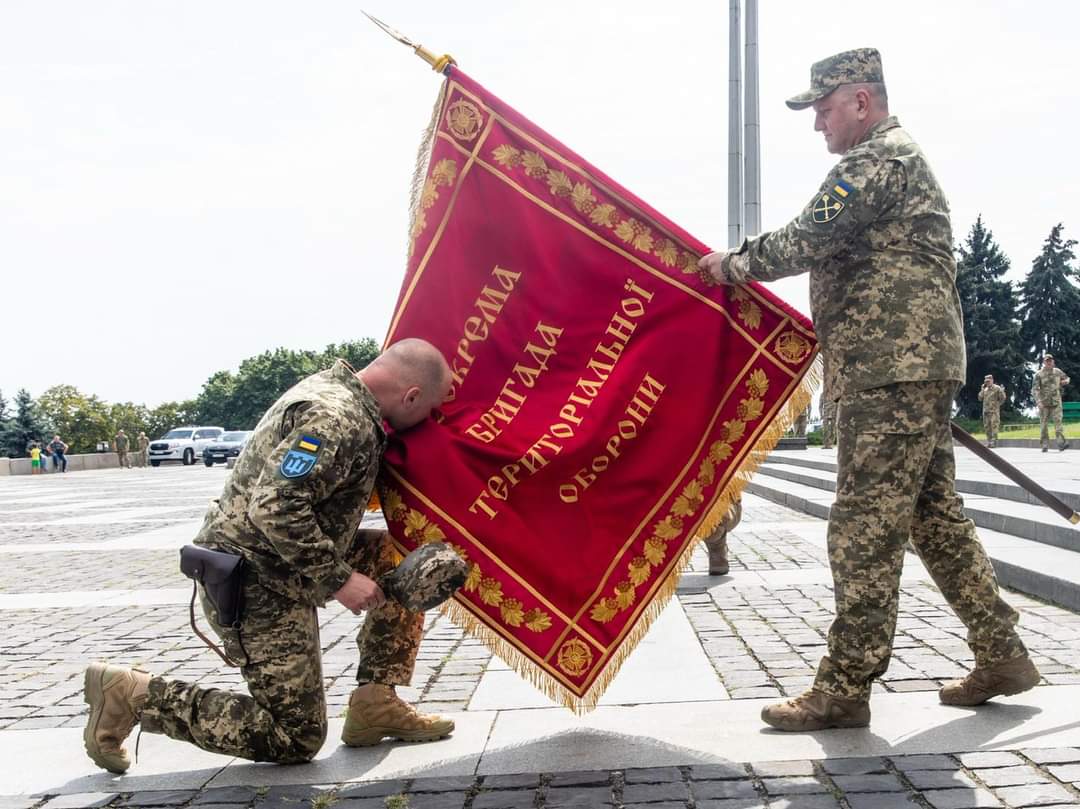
top-left (700, 49), bottom-right (1039, 731)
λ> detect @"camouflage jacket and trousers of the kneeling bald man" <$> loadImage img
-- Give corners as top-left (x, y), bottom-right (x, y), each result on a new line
top-left (141, 360), bottom-right (423, 763)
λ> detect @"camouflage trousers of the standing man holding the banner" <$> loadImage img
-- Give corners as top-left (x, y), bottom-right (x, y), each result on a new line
top-left (814, 381), bottom-right (1027, 699)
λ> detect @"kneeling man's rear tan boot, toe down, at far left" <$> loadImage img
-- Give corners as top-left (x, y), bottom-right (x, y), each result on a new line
top-left (82, 663), bottom-right (150, 774)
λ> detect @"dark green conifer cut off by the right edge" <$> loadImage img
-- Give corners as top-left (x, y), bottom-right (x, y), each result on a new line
top-left (1021, 223), bottom-right (1080, 400)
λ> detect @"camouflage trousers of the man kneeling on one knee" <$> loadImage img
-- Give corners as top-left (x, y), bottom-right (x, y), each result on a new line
top-left (141, 531), bottom-right (423, 764)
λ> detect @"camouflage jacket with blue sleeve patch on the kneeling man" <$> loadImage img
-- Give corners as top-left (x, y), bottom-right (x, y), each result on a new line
top-left (195, 360), bottom-right (386, 606)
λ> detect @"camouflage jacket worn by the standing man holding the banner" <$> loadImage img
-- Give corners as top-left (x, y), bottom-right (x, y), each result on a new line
top-left (723, 118), bottom-right (966, 399)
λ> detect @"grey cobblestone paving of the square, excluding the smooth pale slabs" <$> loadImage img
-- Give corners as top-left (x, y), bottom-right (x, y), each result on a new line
top-left (6, 467), bottom-right (1080, 809)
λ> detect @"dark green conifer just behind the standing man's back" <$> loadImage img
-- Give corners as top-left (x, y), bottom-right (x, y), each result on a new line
top-left (956, 215), bottom-right (1031, 418)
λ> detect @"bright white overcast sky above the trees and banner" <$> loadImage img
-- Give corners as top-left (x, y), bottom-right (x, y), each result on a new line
top-left (0, 0), bottom-right (1080, 405)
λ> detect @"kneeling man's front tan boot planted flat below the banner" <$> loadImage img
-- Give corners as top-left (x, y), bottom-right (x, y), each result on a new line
top-left (341, 683), bottom-right (454, 747)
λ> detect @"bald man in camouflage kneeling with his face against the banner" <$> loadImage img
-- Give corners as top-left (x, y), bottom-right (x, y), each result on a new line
top-left (83, 339), bottom-right (454, 772)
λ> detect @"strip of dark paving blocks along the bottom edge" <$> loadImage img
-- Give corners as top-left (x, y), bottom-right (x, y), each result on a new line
top-left (6, 747), bottom-right (1080, 809)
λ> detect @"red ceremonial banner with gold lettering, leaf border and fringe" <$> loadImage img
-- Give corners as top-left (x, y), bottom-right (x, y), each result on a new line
top-left (380, 67), bottom-right (818, 711)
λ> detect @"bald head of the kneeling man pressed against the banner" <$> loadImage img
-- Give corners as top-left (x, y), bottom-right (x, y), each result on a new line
top-left (356, 337), bottom-right (450, 430)
